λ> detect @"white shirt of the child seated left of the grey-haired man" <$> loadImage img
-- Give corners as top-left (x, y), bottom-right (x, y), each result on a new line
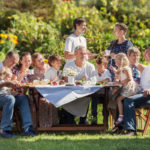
top-left (45, 67), bottom-right (60, 80)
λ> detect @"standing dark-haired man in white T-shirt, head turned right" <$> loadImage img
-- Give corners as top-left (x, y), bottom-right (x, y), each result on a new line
top-left (64, 18), bottom-right (97, 62)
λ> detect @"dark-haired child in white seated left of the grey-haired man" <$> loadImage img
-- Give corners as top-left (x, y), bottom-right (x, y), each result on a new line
top-left (45, 55), bottom-right (61, 82)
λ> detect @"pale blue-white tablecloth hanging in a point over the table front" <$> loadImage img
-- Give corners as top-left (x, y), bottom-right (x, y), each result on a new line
top-left (36, 85), bottom-right (102, 117)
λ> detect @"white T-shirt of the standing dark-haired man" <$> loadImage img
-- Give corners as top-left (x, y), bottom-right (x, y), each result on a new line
top-left (64, 34), bottom-right (87, 62)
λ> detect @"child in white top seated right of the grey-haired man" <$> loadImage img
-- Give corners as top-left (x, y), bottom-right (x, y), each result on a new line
top-left (92, 57), bottom-right (111, 125)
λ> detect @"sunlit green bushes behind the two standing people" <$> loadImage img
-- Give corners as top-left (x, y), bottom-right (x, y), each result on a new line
top-left (0, 0), bottom-right (150, 60)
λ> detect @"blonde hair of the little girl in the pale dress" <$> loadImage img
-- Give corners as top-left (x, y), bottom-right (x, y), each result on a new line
top-left (115, 53), bottom-right (129, 68)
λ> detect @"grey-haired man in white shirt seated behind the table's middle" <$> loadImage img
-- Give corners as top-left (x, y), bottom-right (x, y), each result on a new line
top-left (63, 46), bottom-right (95, 124)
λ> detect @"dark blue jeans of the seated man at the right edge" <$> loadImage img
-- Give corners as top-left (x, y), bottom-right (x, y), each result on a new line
top-left (123, 94), bottom-right (150, 131)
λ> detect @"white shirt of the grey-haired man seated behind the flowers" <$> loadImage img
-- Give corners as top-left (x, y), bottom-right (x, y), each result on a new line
top-left (63, 61), bottom-right (95, 80)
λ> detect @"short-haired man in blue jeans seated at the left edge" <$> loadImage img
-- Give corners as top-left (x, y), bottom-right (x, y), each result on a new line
top-left (0, 51), bottom-right (19, 138)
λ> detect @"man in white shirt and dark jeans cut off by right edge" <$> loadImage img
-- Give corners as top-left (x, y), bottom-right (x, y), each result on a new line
top-left (113, 47), bottom-right (150, 136)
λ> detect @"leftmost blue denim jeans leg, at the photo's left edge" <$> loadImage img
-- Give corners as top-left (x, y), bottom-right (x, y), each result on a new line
top-left (0, 95), bottom-right (15, 131)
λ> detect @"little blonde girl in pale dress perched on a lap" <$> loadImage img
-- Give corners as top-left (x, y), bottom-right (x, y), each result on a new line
top-left (111, 53), bottom-right (137, 125)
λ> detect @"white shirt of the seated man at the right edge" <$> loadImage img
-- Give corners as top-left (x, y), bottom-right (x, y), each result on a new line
top-left (140, 65), bottom-right (150, 90)
